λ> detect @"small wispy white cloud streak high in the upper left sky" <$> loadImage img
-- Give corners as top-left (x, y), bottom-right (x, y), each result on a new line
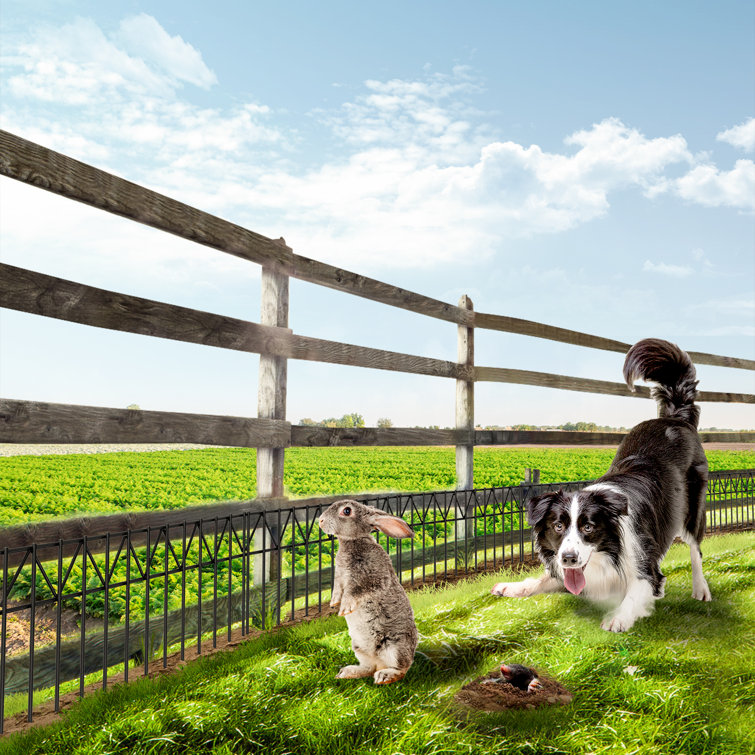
top-left (117, 13), bottom-right (218, 89)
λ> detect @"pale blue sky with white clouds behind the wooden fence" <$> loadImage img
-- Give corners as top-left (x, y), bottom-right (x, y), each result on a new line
top-left (0, 0), bottom-right (755, 429)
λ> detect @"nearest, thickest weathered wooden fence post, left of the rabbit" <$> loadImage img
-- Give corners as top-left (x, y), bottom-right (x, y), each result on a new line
top-left (253, 245), bottom-right (288, 585)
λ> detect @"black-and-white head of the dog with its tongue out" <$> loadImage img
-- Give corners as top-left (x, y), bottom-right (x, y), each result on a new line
top-left (527, 486), bottom-right (628, 594)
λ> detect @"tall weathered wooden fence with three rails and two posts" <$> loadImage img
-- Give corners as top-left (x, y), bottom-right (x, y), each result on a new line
top-left (0, 131), bottom-right (755, 512)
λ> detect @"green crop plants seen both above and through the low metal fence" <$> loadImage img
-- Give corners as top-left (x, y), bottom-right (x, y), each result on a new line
top-left (0, 448), bottom-right (755, 621)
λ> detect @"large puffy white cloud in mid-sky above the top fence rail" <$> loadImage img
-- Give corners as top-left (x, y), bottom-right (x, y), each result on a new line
top-left (224, 110), bottom-right (691, 266)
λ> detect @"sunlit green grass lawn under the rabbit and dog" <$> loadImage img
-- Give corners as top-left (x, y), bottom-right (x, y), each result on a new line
top-left (0, 533), bottom-right (755, 755)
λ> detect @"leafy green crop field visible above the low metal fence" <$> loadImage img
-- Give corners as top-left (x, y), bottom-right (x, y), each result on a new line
top-left (0, 447), bottom-right (755, 527)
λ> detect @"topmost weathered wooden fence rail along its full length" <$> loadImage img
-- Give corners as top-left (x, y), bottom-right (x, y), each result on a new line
top-left (0, 130), bottom-right (755, 370)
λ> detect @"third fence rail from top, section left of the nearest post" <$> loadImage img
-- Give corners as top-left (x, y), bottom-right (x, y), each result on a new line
top-left (0, 399), bottom-right (291, 448)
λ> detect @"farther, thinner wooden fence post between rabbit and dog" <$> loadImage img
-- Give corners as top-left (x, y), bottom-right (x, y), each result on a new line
top-left (456, 294), bottom-right (474, 556)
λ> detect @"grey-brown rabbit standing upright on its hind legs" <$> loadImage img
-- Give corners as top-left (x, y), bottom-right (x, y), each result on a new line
top-left (319, 501), bottom-right (419, 684)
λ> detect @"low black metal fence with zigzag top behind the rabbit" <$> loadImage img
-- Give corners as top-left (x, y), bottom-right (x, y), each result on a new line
top-left (0, 470), bottom-right (755, 732)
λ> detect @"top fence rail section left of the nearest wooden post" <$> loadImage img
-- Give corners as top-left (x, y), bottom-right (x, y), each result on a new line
top-left (0, 131), bottom-right (291, 264)
